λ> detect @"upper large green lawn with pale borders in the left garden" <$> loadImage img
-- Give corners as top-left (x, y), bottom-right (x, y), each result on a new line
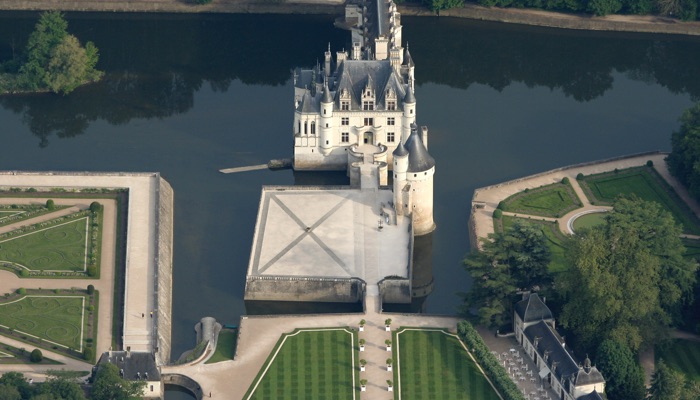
top-left (0, 217), bottom-right (89, 271)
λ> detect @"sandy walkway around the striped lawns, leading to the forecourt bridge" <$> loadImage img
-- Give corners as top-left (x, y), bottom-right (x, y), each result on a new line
top-left (162, 294), bottom-right (460, 399)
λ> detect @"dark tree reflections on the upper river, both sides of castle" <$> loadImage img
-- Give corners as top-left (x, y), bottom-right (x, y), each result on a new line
top-left (0, 12), bottom-right (700, 147)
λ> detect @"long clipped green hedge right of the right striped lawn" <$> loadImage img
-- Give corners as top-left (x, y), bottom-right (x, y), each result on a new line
top-left (457, 321), bottom-right (526, 400)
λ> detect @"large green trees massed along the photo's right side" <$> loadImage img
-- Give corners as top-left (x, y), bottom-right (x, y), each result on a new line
top-left (463, 104), bottom-right (700, 400)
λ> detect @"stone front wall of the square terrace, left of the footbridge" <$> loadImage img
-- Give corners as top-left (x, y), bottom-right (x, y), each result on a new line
top-left (243, 276), bottom-right (365, 303)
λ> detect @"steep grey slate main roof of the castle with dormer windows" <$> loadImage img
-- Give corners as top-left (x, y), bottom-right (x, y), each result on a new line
top-left (334, 60), bottom-right (406, 110)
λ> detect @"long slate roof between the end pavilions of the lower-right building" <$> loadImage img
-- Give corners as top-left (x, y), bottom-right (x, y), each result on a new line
top-left (524, 321), bottom-right (579, 389)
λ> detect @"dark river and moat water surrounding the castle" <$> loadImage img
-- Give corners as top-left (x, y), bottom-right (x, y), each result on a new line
top-left (0, 12), bottom-right (700, 399)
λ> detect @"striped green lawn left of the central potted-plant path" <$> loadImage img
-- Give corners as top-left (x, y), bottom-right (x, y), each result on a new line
top-left (244, 329), bottom-right (360, 400)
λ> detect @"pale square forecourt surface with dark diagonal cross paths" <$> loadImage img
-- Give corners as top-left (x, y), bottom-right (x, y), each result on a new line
top-left (248, 186), bottom-right (411, 286)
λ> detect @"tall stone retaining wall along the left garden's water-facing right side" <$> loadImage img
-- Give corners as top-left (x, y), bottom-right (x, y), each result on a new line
top-left (155, 178), bottom-right (174, 365)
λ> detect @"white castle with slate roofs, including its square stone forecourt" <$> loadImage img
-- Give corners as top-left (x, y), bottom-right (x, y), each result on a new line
top-left (244, 0), bottom-right (435, 304)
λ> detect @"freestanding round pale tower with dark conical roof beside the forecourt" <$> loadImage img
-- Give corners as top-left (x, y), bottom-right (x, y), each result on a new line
top-left (402, 124), bottom-right (435, 236)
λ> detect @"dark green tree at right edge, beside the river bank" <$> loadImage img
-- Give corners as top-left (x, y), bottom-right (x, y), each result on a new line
top-left (666, 103), bottom-right (700, 203)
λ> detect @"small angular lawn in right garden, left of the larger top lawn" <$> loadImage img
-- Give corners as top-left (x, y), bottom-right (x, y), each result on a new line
top-left (500, 183), bottom-right (582, 218)
